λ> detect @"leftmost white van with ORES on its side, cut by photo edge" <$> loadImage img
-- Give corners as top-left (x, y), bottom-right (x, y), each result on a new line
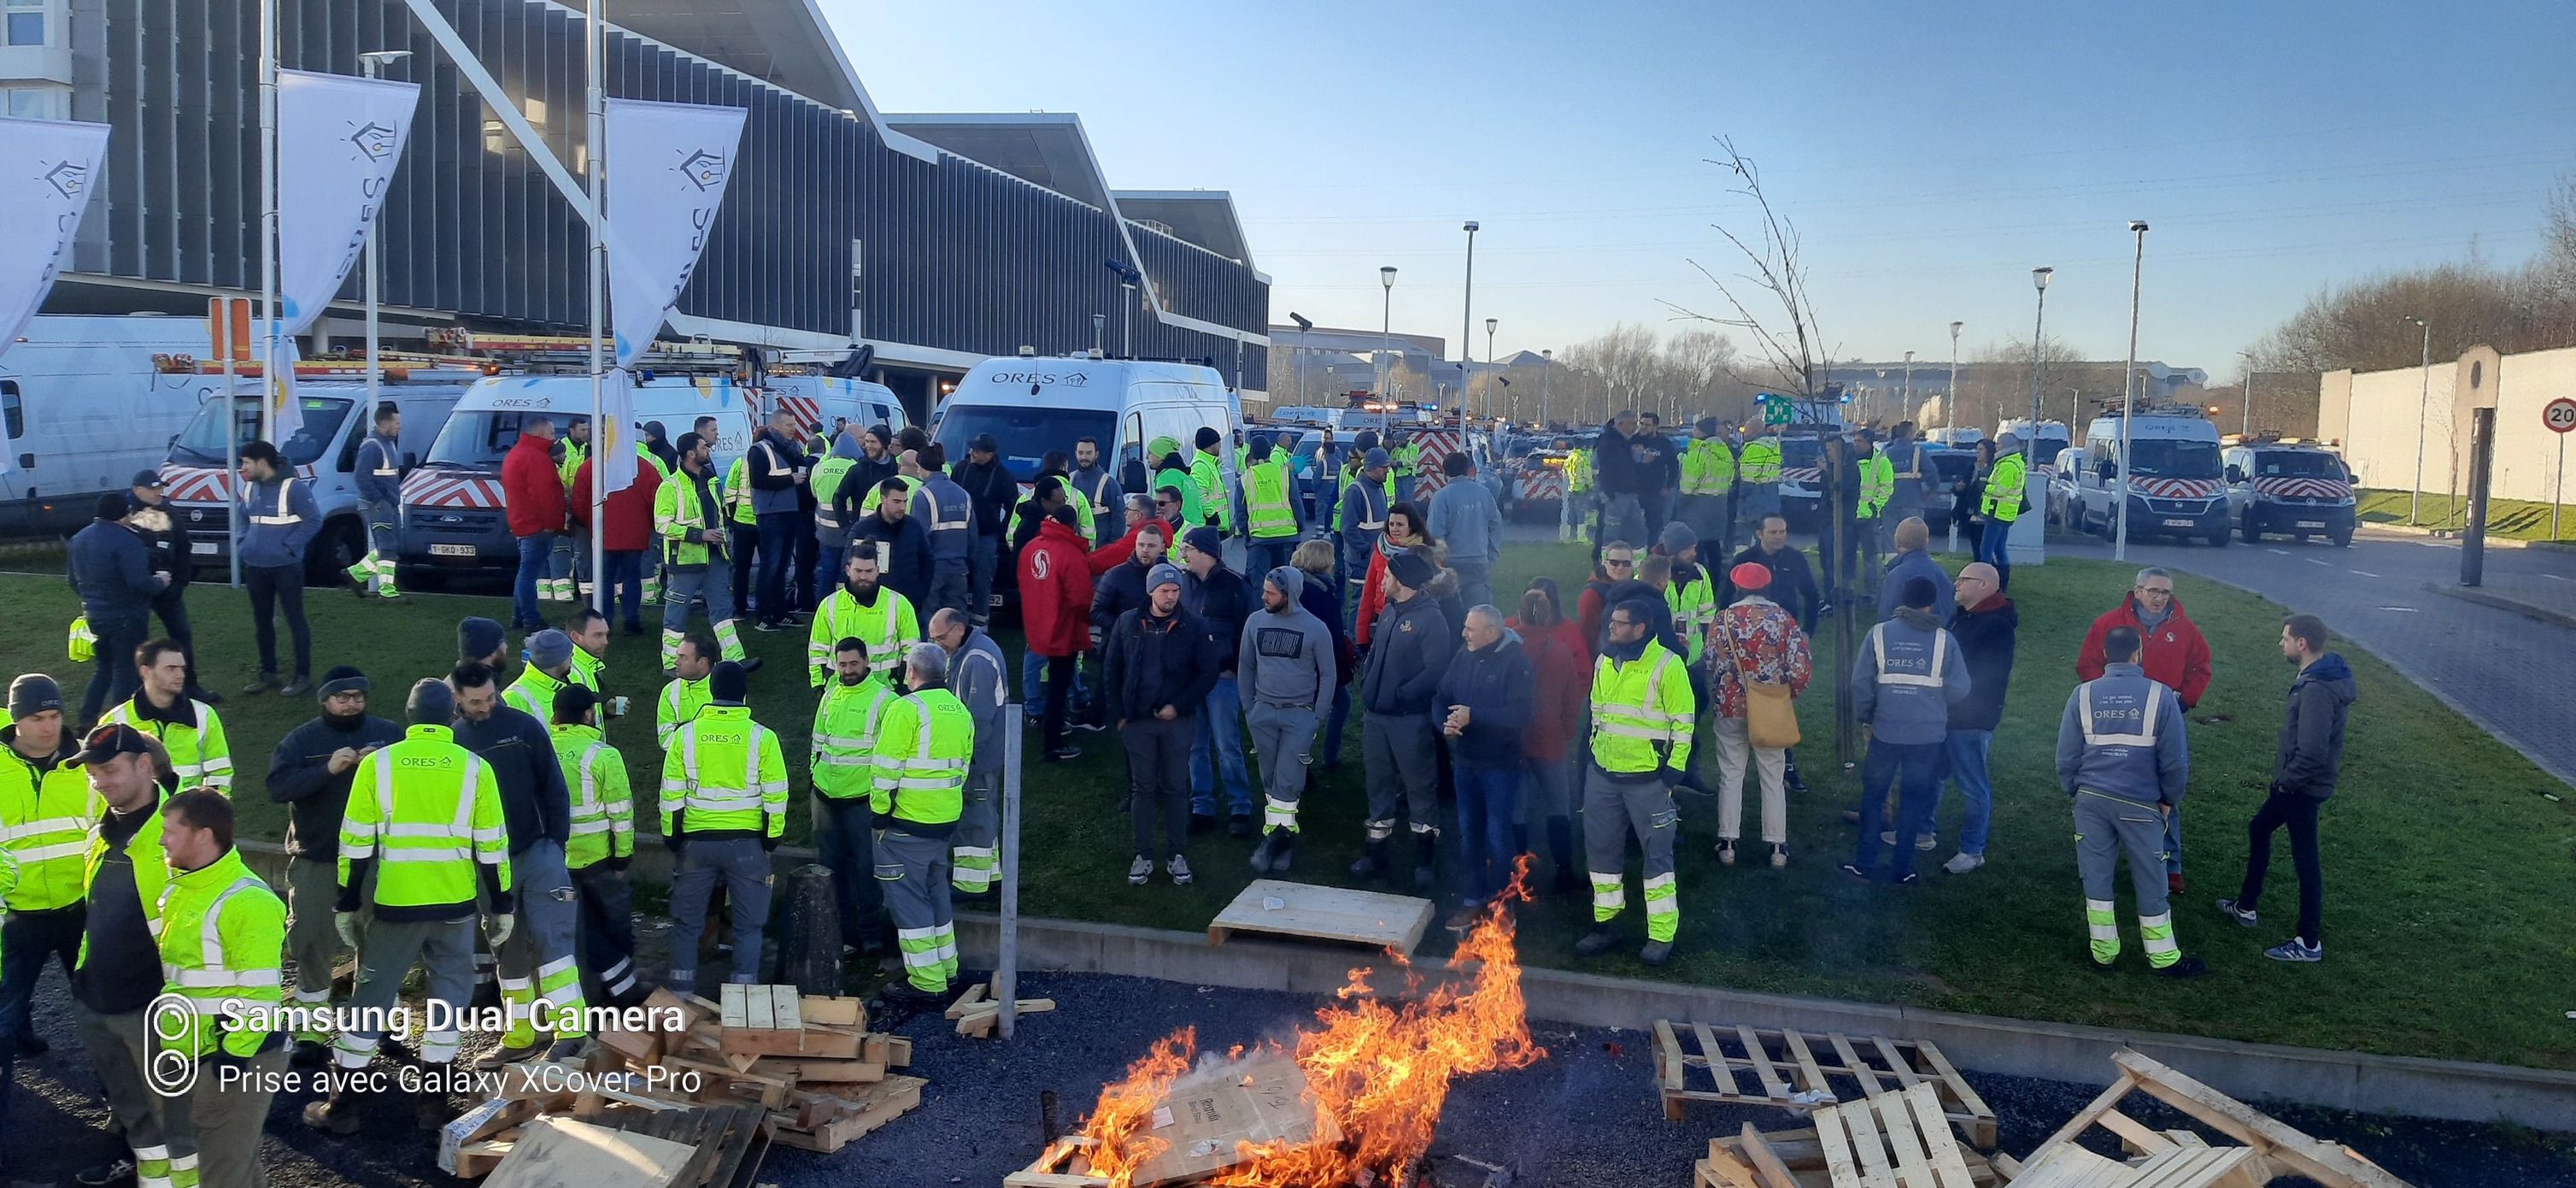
top-left (0, 315), bottom-right (224, 536)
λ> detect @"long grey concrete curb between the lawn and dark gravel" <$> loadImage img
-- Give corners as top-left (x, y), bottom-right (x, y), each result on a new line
top-left (959, 912), bottom-right (2576, 1132)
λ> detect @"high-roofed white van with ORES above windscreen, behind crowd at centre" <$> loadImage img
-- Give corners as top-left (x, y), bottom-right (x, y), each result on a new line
top-left (930, 356), bottom-right (1244, 492)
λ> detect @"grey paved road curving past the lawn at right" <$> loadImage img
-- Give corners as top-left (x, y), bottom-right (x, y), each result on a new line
top-left (2048, 528), bottom-right (2576, 784)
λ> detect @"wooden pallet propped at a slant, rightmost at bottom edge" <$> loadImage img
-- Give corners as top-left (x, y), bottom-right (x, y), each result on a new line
top-left (1994, 1049), bottom-right (2409, 1188)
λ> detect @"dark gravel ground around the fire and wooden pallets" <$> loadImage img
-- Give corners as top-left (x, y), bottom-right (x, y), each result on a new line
top-left (0, 974), bottom-right (2576, 1188)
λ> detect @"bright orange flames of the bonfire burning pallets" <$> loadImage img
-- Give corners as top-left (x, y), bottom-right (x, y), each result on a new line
top-left (1084, 858), bottom-right (1546, 1188)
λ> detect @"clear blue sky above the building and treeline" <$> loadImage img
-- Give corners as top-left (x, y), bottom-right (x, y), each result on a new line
top-left (819, 0), bottom-right (2576, 376)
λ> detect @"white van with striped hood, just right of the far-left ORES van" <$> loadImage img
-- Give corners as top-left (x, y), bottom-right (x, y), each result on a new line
top-left (162, 363), bottom-right (482, 585)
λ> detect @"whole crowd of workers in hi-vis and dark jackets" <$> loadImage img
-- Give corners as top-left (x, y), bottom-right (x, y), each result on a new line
top-left (15, 402), bottom-right (2357, 1188)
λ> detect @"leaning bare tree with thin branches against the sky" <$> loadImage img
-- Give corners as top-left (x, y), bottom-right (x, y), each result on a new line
top-left (1664, 137), bottom-right (1832, 415)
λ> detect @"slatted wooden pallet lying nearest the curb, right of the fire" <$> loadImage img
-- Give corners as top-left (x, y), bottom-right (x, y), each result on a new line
top-left (1654, 1020), bottom-right (1994, 1150)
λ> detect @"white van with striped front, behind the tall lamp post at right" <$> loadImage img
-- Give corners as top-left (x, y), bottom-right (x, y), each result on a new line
top-left (2068, 404), bottom-right (2233, 546)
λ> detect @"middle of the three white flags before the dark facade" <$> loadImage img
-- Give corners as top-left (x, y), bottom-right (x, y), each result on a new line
top-left (268, 69), bottom-right (420, 438)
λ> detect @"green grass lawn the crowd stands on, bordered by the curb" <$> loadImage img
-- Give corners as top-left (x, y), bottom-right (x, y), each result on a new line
top-left (15, 544), bottom-right (2576, 1067)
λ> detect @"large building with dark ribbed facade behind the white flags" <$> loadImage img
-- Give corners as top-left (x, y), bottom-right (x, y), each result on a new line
top-left (45, 0), bottom-right (1270, 412)
